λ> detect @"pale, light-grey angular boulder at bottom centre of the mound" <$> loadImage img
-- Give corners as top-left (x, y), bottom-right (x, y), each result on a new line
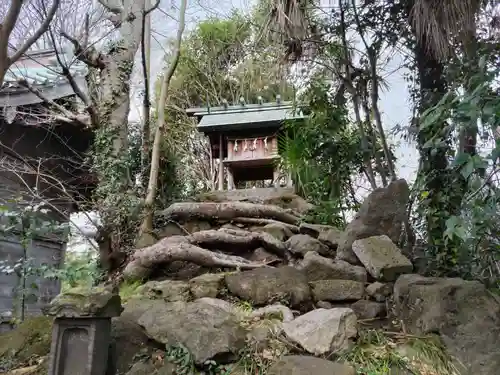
top-left (283, 308), bottom-right (358, 355)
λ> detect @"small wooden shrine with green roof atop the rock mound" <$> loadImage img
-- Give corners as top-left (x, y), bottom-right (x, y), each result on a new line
top-left (187, 96), bottom-right (305, 190)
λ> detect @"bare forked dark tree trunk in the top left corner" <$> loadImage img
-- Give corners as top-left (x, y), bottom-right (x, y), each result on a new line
top-left (0, 0), bottom-right (60, 87)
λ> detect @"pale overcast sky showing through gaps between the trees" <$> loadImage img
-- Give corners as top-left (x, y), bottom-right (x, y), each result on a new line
top-left (68, 0), bottom-right (418, 251)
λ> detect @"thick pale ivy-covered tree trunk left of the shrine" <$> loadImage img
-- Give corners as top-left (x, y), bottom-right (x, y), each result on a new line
top-left (62, 0), bottom-right (159, 264)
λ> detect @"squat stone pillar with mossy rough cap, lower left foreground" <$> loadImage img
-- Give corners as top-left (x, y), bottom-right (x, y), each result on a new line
top-left (44, 287), bottom-right (123, 375)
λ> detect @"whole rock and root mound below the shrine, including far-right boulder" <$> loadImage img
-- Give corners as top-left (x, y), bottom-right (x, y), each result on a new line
top-left (3, 180), bottom-right (500, 375)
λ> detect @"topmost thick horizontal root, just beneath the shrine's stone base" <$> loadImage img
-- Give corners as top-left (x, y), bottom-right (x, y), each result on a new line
top-left (160, 202), bottom-right (299, 225)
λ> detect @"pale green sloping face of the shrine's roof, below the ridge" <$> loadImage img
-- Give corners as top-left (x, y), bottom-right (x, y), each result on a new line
top-left (198, 106), bottom-right (306, 133)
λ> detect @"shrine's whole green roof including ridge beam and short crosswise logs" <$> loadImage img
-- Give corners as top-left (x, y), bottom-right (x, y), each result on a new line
top-left (191, 103), bottom-right (306, 133)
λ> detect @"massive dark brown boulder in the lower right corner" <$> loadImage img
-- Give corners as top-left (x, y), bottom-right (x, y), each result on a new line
top-left (394, 275), bottom-right (500, 375)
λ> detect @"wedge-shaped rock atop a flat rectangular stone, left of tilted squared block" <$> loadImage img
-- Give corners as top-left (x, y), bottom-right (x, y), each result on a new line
top-left (298, 251), bottom-right (367, 282)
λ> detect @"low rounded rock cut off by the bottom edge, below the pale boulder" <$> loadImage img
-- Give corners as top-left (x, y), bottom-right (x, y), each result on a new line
top-left (267, 355), bottom-right (356, 375)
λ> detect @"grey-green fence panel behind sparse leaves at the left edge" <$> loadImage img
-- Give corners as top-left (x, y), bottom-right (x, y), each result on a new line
top-left (0, 236), bottom-right (66, 333)
